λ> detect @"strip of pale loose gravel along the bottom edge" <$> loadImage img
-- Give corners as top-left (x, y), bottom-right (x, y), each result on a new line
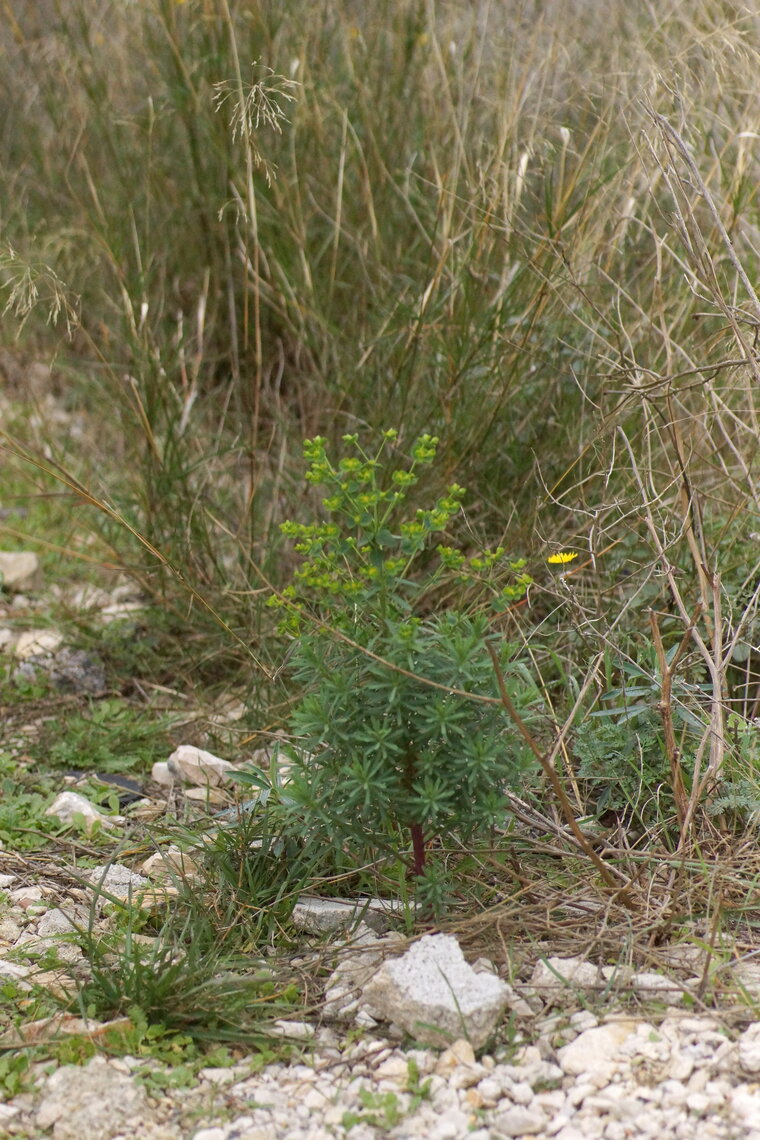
top-left (7, 1003), bottom-right (760, 1140)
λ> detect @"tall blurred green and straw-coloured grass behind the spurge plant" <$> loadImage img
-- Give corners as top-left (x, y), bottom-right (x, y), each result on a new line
top-left (0, 0), bottom-right (760, 747)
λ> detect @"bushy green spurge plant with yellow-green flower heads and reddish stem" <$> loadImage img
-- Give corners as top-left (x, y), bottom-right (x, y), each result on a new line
top-left (272, 431), bottom-right (537, 909)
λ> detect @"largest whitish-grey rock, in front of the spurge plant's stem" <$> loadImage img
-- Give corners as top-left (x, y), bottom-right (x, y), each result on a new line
top-left (361, 934), bottom-right (507, 1049)
